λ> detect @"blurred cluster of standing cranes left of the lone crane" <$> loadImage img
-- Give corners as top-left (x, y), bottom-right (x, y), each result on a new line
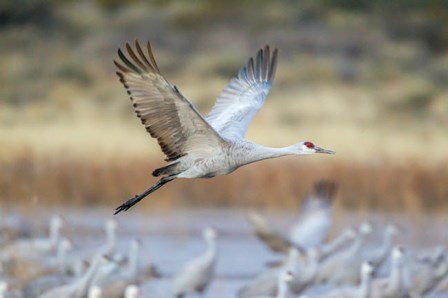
top-left (0, 216), bottom-right (140, 298)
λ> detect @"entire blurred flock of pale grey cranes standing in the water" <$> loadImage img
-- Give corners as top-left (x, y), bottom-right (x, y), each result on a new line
top-left (0, 182), bottom-right (448, 298)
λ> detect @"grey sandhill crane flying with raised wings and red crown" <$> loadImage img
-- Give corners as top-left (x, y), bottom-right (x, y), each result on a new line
top-left (114, 41), bottom-right (334, 214)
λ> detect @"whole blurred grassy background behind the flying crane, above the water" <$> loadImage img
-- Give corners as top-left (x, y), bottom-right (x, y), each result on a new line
top-left (0, 0), bottom-right (448, 211)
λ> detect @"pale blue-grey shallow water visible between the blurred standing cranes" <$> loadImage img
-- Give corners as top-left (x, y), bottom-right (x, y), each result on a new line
top-left (3, 208), bottom-right (448, 298)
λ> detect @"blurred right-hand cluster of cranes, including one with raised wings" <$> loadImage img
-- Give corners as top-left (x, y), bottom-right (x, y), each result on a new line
top-left (238, 182), bottom-right (448, 298)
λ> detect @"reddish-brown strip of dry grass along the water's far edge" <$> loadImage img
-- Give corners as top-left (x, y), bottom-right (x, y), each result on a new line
top-left (0, 151), bottom-right (448, 212)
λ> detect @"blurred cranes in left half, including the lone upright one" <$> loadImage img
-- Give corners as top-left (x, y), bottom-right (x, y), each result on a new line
top-left (0, 211), bottom-right (217, 298)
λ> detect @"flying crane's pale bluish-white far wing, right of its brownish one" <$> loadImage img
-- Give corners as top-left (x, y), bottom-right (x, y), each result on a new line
top-left (206, 46), bottom-right (277, 139)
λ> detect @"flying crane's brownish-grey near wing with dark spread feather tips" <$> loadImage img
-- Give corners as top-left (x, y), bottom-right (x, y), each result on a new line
top-left (114, 40), bottom-right (223, 161)
